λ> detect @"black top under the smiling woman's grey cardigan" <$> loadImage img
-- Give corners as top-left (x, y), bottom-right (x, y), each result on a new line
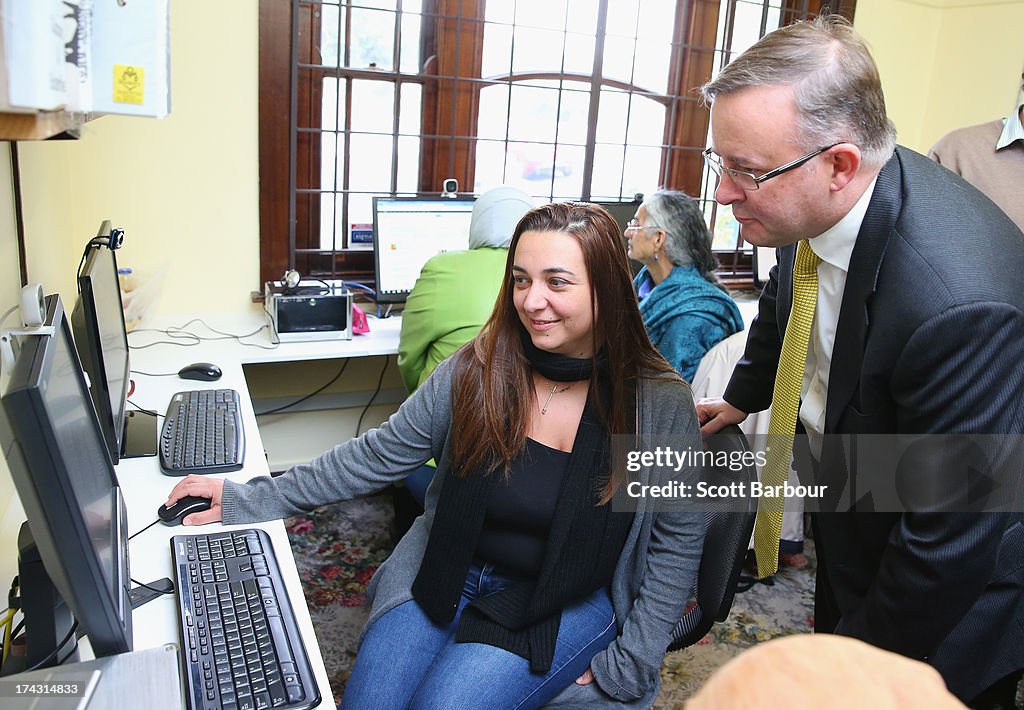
top-left (476, 438), bottom-right (570, 579)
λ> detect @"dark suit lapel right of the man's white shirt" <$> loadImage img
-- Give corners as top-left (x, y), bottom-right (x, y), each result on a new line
top-left (825, 149), bottom-right (903, 433)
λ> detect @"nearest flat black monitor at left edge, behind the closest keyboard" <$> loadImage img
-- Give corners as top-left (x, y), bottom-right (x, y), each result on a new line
top-left (0, 295), bottom-right (132, 657)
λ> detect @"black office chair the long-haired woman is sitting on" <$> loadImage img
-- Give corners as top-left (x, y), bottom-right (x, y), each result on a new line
top-left (668, 424), bottom-right (758, 651)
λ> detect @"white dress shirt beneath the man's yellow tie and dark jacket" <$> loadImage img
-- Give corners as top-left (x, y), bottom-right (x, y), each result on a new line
top-left (800, 178), bottom-right (877, 457)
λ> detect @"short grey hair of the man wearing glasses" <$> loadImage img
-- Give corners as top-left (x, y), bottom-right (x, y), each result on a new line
top-left (700, 14), bottom-right (896, 167)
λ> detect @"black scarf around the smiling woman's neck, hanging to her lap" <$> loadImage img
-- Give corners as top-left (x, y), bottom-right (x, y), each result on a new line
top-left (413, 334), bottom-right (634, 673)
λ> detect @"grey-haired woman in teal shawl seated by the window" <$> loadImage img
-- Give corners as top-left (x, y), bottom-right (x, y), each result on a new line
top-left (626, 185), bottom-right (743, 382)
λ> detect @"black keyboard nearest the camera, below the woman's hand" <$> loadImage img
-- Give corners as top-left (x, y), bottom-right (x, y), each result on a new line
top-left (171, 530), bottom-right (321, 710)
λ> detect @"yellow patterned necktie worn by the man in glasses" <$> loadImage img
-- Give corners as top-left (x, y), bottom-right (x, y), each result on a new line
top-left (754, 241), bottom-right (821, 579)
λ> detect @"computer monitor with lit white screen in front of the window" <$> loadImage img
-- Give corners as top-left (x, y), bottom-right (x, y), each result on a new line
top-left (374, 197), bottom-right (475, 303)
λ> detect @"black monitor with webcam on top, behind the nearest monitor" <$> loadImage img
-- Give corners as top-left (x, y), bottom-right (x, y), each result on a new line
top-left (71, 228), bottom-right (157, 463)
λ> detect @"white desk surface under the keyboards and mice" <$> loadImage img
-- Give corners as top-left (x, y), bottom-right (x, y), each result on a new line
top-left (117, 314), bottom-right (401, 707)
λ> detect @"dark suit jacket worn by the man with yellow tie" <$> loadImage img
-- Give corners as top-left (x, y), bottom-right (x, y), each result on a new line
top-left (725, 148), bottom-right (1024, 700)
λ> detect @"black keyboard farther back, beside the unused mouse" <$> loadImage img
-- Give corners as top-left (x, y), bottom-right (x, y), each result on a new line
top-left (160, 389), bottom-right (246, 475)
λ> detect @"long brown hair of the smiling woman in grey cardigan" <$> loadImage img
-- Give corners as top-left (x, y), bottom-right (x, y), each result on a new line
top-left (451, 202), bottom-right (673, 503)
